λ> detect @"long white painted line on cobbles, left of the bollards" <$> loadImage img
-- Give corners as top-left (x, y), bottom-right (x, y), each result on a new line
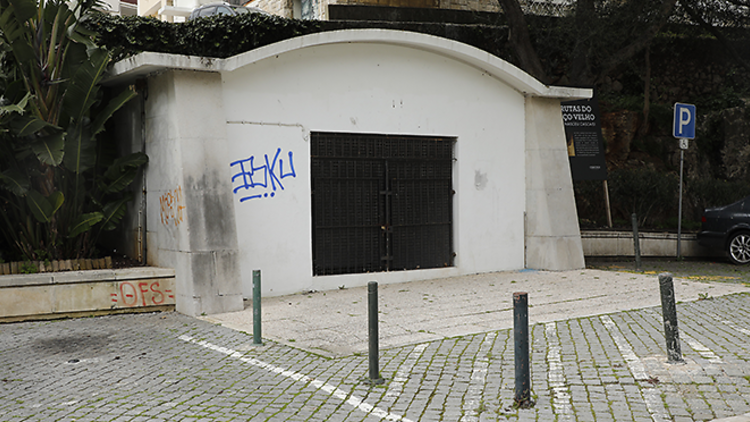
top-left (178, 335), bottom-right (412, 422)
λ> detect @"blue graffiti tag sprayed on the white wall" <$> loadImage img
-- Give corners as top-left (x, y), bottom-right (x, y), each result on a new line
top-left (229, 148), bottom-right (297, 202)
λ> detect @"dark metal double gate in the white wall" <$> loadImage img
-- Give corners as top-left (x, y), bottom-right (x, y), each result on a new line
top-left (310, 133), bottom-right (455, 275)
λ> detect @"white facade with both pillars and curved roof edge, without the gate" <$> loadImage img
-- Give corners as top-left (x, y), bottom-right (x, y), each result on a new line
top-left (109, 30), bottom-right (591, 314)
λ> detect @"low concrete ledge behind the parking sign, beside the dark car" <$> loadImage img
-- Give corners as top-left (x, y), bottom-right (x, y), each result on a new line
top-left (581, 230), bottom-right (723, 257)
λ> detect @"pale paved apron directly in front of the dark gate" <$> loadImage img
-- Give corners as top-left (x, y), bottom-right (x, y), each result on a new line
top-left (206, 269), bottom-right (750, 357)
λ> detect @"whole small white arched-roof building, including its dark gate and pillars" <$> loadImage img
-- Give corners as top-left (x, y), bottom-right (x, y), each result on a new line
top-left (108, 30), bottom-right (591, 314)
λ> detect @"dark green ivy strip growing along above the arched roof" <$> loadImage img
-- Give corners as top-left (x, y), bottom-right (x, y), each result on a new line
top-left (86, 13), bottom-right (509, 61)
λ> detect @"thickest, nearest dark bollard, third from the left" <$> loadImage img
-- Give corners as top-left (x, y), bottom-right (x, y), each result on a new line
top-left (513, 292), bottom-right (533, 408)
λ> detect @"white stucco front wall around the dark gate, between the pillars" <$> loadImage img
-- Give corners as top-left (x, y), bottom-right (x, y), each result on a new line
top-left (223, 43), bottom-right (525, 294)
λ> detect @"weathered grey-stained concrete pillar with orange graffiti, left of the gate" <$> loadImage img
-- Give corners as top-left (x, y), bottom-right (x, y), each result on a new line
top-left (145, 70), bottom-right (243, 315)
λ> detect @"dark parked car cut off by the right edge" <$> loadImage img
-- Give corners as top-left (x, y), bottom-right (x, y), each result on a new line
top-left (698, 196), bottom-right (750, 265)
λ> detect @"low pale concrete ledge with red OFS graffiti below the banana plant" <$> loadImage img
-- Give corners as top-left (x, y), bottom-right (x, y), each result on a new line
top-left (0, 267), bottom-right (175, 322)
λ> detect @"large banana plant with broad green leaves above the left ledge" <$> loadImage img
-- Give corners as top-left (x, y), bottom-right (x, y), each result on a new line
top-left (0, 0), bottom-right (148, 259)
